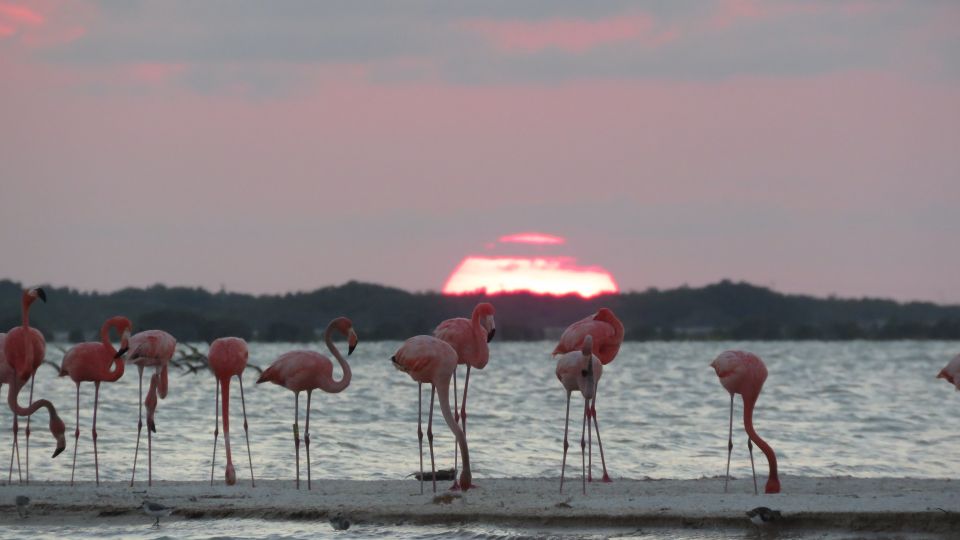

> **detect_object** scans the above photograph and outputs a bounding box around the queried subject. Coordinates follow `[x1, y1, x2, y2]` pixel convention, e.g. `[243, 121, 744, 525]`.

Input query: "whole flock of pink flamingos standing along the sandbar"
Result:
[0, 288, 960, 493]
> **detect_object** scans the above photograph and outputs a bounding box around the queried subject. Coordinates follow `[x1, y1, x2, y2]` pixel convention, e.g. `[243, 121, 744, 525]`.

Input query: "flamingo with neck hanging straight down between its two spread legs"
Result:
[207, 337, 256, 487]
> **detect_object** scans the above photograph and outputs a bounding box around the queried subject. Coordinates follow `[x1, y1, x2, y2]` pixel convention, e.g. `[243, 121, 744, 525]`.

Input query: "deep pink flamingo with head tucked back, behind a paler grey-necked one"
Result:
[553, 308, 623, 482]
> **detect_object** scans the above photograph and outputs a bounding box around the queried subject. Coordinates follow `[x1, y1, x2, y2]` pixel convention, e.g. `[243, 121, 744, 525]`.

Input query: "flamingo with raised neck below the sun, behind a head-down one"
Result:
[433, 302, 497, 474]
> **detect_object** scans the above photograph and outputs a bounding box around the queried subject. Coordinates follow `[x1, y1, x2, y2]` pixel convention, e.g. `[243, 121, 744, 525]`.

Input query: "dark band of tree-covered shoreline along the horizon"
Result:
[0, 280, 960, 342]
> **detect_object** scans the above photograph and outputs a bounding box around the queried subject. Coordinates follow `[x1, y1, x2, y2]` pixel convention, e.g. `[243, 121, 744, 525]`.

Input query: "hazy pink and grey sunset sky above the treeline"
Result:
[0, 0, 960, 303]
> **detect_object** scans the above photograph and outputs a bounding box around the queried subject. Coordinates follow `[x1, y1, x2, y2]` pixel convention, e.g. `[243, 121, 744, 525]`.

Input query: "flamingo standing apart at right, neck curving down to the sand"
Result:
[710, 351, 780, 493]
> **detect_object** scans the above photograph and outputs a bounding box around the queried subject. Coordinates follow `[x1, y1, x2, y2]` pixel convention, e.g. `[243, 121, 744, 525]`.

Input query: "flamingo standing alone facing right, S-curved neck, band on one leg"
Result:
[257, 317, 357, 489]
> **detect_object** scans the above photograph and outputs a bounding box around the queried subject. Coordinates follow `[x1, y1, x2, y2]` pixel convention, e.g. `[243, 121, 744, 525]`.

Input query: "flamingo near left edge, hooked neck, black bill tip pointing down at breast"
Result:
[60, 317, 132, 486]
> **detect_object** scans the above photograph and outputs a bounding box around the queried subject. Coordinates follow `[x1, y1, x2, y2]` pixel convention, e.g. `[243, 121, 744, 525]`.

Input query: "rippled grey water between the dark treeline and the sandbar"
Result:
[9, 336, 960, 481]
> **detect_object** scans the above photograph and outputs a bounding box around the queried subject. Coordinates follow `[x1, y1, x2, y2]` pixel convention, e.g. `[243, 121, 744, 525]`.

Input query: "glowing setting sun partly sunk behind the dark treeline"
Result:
[443, 233, 619, 298]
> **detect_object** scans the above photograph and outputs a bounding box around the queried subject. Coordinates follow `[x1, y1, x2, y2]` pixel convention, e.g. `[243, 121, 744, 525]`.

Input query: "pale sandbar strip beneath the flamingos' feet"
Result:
[0, 476, 960, 532]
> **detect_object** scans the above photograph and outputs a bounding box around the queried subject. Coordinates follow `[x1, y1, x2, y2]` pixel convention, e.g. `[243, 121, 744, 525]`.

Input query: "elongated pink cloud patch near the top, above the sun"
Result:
[466, 14, 673, 53]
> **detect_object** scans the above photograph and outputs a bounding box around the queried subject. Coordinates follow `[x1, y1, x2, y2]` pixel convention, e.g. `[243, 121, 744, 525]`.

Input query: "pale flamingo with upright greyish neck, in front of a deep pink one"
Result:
[557, 334, 603, 495]
